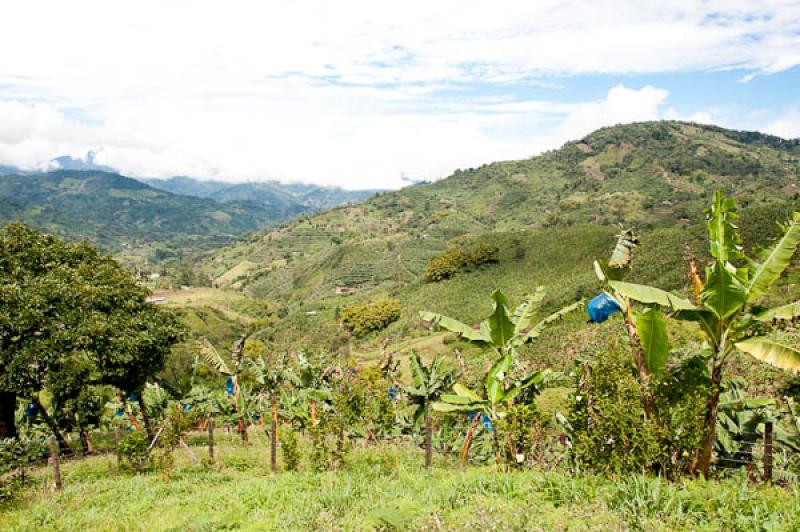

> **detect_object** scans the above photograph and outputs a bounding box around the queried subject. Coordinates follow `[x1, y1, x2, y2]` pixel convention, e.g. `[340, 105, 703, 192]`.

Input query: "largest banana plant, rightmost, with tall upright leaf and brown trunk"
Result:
[608, 191, 800, 477]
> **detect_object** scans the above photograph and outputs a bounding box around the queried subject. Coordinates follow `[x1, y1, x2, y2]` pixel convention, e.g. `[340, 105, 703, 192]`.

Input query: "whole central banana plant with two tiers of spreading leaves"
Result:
[420, 287, 583, 461]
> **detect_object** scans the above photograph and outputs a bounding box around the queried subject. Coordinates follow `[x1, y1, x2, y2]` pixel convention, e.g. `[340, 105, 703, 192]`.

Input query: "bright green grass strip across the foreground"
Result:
[0, 431, 800, 530]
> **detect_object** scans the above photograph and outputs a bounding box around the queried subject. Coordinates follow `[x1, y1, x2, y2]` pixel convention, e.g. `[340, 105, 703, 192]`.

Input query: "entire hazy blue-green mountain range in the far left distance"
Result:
[0, 166, 380, 265]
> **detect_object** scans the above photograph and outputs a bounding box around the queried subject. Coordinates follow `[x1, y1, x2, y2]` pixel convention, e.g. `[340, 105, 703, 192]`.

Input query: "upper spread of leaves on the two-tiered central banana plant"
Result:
[419, 286, 583, 355]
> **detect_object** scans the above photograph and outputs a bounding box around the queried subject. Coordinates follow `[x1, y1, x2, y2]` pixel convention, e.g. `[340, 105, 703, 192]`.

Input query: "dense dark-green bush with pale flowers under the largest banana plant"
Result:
[569, 350, 707, 477]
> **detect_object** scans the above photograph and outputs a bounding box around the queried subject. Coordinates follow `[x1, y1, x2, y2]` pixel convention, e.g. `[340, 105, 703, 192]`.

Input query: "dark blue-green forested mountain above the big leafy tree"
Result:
[0, 170, 276, 263]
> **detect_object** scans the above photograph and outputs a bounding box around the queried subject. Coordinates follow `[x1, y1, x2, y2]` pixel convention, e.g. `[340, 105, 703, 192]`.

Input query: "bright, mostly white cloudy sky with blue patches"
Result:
[0, 0, 800, 188]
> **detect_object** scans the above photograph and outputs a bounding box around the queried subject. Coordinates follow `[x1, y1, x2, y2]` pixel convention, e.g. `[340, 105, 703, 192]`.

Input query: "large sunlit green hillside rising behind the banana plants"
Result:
[198, 122, 800, 370]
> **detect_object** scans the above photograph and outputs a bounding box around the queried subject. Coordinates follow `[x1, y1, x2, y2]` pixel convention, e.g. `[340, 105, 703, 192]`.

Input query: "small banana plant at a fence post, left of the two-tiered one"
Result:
[404, 349, 453, 467]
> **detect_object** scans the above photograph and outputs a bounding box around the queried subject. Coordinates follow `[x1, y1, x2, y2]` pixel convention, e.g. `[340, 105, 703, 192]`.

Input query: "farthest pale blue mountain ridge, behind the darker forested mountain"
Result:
[143, 177, 379, 214]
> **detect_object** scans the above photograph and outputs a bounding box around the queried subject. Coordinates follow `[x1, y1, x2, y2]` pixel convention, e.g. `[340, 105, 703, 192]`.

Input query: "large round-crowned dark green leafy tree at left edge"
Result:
[0, 224, 182, 446]
